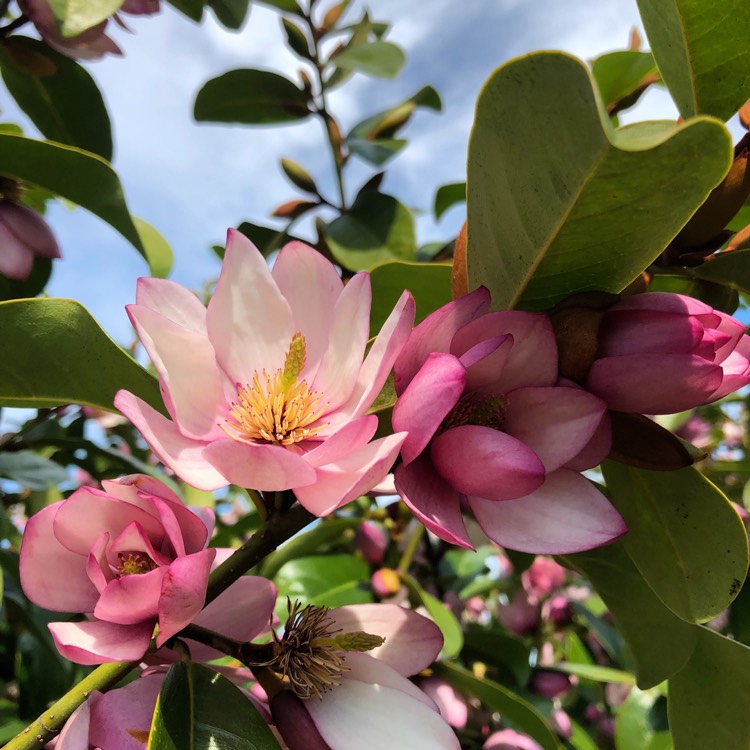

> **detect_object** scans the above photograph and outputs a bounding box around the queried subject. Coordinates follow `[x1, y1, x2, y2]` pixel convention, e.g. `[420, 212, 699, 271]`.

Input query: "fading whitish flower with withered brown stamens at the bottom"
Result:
[264, 604, 459, 750]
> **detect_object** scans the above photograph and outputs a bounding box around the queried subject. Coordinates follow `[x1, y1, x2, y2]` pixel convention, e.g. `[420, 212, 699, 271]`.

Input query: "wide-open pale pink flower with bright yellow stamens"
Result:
[115, 230, 414, 516]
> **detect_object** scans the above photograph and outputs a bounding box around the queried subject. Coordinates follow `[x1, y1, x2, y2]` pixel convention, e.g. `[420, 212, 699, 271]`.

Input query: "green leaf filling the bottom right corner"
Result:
[669, 628, 750, 750]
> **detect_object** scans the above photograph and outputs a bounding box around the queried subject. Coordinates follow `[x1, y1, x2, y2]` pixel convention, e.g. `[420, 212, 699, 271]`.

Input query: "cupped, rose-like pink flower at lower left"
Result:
[20, 475, 225, 664]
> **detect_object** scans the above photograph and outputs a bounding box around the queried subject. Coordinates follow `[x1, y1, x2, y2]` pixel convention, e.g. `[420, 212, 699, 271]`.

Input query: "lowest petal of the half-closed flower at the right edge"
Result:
[586, 354, 722, 414]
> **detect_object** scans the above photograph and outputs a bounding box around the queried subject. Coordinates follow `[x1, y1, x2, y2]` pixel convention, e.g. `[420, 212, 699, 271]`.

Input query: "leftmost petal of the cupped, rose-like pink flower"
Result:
[19, 500, 99, 612]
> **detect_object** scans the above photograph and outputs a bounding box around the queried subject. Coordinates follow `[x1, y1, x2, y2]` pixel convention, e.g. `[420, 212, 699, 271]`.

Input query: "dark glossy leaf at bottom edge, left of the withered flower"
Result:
[148, 662, 280, 750]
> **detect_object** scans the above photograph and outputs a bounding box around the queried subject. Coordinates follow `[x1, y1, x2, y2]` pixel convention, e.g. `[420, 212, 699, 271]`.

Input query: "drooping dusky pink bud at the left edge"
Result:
[0, 200, 60, 281]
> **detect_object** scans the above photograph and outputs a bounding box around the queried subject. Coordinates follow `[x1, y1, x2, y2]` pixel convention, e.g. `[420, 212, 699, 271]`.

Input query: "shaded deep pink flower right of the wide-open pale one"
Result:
[393, 288, 626, 554]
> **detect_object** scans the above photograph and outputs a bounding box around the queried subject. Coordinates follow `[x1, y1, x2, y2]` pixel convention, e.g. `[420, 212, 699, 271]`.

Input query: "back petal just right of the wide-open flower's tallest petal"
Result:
[271, 242, 344, 382]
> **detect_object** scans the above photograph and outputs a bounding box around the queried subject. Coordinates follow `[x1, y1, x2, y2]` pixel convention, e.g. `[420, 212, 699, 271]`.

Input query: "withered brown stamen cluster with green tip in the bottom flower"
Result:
[269, 601, 385, 699]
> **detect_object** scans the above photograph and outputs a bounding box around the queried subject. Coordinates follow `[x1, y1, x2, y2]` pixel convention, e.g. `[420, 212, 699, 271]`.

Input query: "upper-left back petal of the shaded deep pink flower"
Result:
[394, 287, 490, 395]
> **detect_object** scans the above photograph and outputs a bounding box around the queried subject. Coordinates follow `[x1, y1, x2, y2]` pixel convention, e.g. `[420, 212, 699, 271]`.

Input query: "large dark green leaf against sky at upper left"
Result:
[0, 36, 112, 161]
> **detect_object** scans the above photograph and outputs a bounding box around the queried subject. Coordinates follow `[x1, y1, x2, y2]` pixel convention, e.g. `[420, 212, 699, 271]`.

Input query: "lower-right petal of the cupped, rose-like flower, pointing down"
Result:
[156, 549, 216, 646]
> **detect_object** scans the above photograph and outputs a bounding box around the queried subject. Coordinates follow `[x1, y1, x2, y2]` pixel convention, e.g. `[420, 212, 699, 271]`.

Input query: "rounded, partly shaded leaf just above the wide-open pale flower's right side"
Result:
[326, 190, 417, 271]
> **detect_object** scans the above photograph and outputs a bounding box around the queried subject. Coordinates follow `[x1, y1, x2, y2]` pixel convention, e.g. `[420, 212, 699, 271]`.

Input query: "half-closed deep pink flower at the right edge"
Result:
[586, 292, 750, 414]
